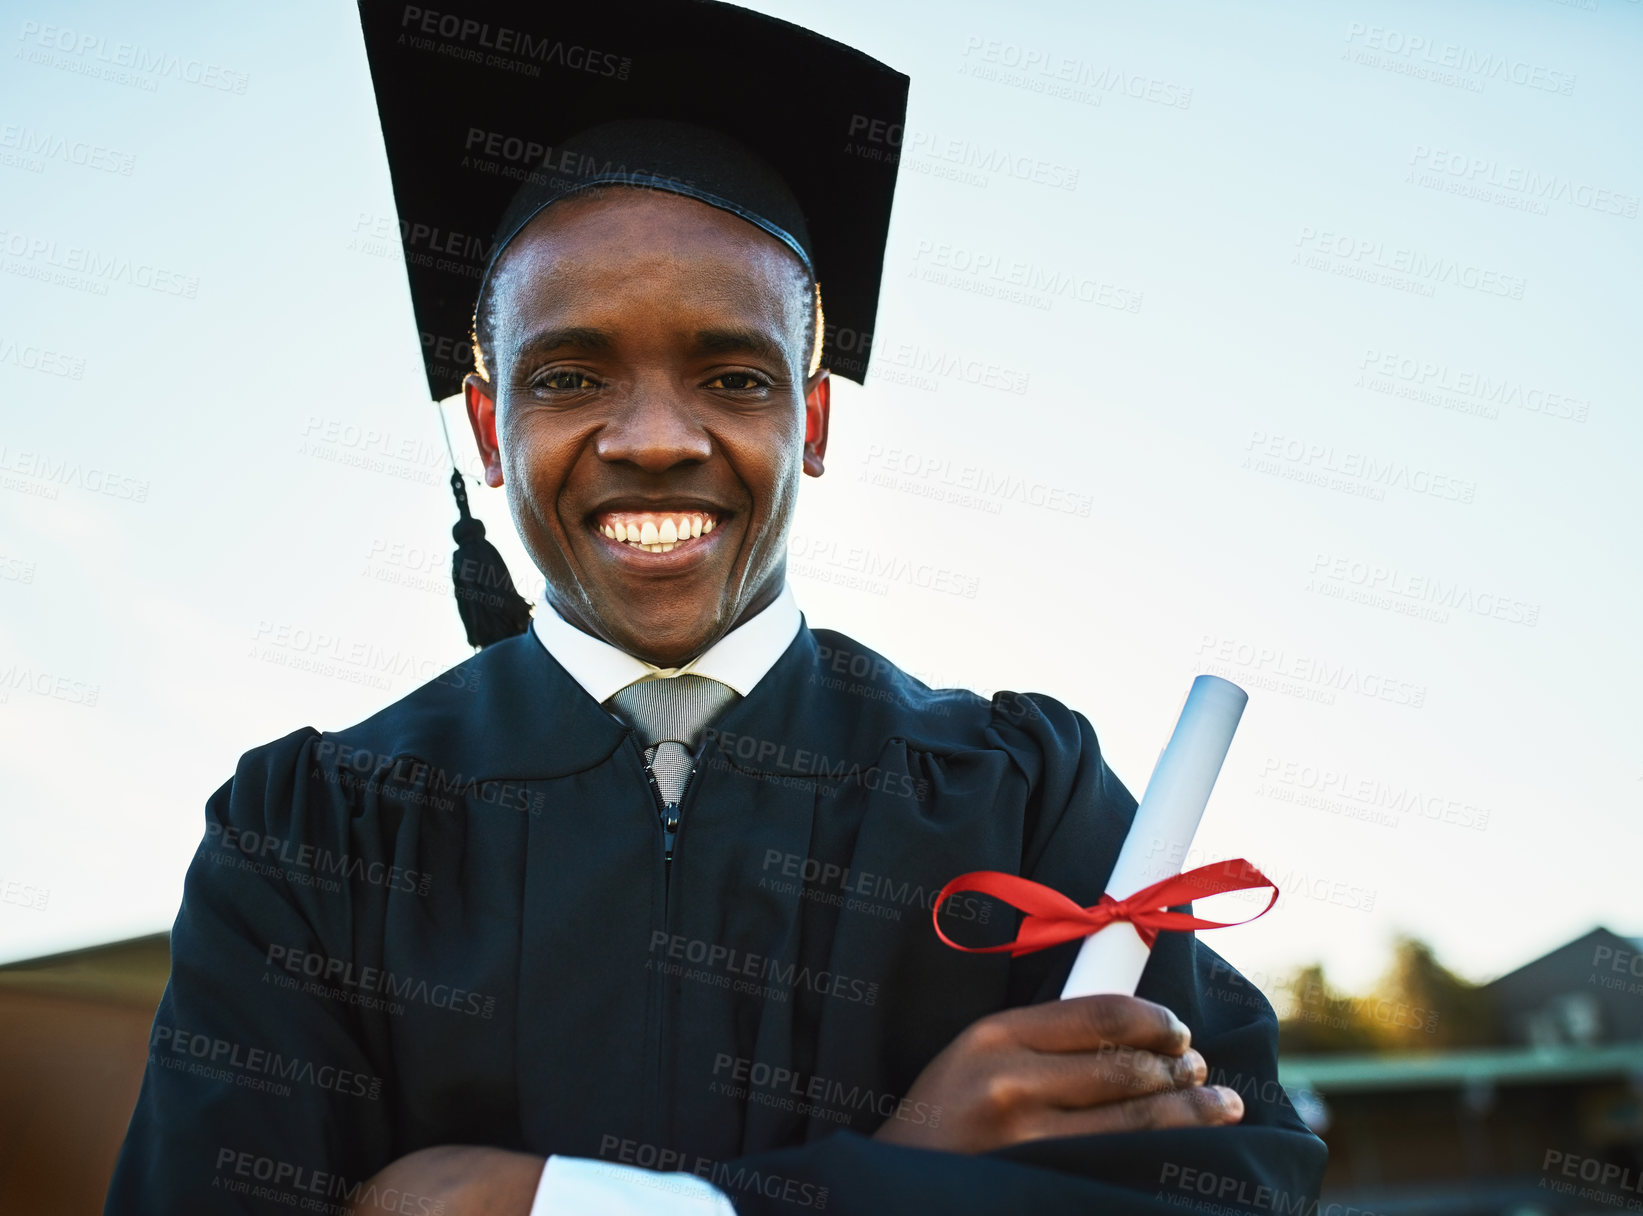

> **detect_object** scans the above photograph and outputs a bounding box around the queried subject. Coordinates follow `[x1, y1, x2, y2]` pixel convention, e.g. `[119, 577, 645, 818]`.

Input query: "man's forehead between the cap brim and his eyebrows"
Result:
[491, 186, 810, 320]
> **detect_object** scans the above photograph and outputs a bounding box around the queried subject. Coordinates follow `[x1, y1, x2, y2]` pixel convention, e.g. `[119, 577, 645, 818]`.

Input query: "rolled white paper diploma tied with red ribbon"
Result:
[1061, 675, 1249, 997]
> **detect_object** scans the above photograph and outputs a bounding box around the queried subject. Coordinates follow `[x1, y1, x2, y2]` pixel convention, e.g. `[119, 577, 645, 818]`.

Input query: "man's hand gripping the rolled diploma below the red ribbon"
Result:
[872, 996, 1244, 1152]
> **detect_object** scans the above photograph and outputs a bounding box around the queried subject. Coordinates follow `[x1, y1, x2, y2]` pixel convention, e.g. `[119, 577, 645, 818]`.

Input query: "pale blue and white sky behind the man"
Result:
[0, 0, 1643, 986]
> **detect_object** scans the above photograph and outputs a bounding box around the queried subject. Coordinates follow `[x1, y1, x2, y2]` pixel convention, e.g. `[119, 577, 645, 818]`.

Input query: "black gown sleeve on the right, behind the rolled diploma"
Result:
[715, 693, 1328, 1216]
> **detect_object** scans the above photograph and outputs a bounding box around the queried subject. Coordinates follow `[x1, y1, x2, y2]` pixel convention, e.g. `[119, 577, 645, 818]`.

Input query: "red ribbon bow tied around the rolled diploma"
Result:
[930, 858, 1278, 955]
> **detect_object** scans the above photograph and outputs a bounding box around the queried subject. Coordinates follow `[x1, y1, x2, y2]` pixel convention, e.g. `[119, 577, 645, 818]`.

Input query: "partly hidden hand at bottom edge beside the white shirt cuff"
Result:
[348, 1144, 547, 1216]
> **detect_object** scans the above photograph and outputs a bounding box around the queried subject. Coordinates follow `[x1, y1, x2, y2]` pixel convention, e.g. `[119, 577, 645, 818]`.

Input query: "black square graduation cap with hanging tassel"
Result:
[360, 0, 909, 646]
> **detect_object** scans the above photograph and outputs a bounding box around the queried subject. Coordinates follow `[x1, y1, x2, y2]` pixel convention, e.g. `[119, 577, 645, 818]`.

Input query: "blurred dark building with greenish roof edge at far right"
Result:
[1280, 928, 1643, 1216]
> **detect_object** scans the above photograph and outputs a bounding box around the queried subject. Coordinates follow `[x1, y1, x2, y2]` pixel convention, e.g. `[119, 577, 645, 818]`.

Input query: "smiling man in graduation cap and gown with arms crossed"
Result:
[108, 2, 1323, 1216]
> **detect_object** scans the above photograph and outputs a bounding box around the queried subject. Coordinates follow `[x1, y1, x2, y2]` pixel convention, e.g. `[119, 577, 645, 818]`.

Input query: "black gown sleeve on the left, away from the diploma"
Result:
[104, 730, 393, 1216]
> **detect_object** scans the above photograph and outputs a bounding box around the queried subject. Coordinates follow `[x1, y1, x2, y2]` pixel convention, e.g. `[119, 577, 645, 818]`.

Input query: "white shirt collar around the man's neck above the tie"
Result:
[531, 583, 803, 705]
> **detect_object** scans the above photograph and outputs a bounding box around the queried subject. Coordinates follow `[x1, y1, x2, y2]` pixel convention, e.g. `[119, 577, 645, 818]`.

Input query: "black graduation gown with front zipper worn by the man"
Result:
[107, 628, 1326, 1216]
